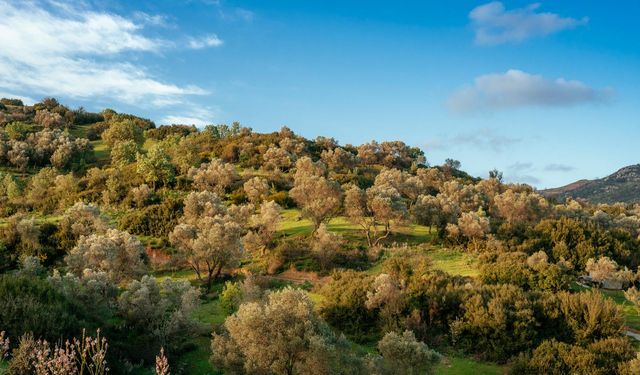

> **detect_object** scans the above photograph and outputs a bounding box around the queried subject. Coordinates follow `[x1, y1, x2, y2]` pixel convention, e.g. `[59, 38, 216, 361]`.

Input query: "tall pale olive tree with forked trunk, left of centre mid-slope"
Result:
[169, 191, 244, 288]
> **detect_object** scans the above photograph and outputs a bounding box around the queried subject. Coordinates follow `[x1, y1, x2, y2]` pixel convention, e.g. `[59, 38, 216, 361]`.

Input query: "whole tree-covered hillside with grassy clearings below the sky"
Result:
[0, 98, 640, 374]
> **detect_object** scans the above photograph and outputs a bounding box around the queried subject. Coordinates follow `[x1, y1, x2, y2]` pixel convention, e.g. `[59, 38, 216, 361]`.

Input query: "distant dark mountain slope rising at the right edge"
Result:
[541, 164, 640, 203]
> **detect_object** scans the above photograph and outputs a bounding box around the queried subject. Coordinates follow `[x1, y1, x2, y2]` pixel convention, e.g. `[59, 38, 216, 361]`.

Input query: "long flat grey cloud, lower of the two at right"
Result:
[448, 69, 613, 113]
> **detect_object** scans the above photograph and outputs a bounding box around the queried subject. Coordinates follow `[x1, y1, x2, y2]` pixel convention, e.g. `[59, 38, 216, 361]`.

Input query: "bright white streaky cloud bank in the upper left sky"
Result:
[0, 1, 205, 103]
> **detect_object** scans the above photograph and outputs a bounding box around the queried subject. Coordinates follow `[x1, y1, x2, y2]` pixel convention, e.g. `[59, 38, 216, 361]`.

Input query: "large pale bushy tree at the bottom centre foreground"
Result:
[211, 288, 360, 375]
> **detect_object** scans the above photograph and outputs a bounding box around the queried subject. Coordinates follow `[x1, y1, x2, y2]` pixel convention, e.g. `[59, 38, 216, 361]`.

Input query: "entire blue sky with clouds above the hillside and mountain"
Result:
[0, 0, 640, 189]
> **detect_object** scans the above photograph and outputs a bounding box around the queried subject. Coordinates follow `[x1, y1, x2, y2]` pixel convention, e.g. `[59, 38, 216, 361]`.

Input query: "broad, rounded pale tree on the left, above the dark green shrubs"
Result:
[65, 229, 147, 282]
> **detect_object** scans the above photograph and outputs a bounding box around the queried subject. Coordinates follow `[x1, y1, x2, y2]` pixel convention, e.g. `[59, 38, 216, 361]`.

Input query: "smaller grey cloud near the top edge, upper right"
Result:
[469, 1, 589, 45]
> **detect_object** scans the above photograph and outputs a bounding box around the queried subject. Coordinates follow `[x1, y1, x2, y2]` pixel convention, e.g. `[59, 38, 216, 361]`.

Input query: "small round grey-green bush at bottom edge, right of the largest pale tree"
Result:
[378, 331, 442, 375]
